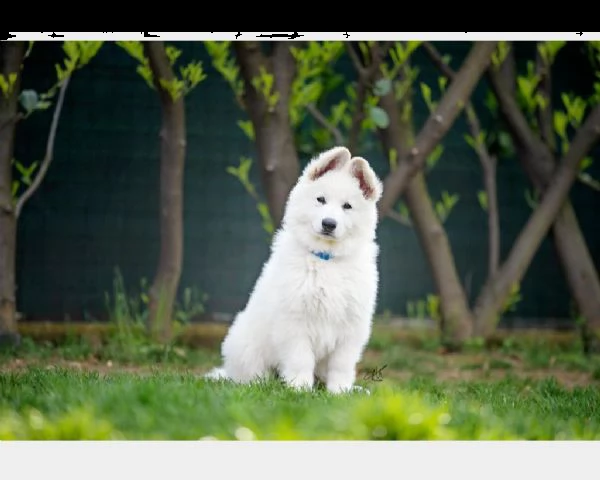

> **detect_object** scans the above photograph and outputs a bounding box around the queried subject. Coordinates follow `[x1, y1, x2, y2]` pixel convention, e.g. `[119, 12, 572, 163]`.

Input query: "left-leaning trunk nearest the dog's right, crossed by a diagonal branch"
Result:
[380, 68, 473, 348]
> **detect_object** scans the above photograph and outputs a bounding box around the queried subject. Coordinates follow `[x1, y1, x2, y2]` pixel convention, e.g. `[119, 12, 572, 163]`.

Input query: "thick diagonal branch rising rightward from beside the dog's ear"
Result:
[379, 42, 498, 218]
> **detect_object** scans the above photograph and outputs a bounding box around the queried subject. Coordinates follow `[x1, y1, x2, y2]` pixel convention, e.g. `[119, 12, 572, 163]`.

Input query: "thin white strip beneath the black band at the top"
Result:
[3, 32, 600, 41]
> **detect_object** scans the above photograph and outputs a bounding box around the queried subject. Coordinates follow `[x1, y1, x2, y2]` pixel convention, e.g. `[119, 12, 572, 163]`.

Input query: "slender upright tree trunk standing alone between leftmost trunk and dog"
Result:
[144, 41, 186, 342]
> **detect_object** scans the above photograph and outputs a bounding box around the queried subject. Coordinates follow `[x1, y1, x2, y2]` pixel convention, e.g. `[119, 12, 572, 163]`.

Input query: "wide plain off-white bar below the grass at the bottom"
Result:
[0, 441, 600, 480]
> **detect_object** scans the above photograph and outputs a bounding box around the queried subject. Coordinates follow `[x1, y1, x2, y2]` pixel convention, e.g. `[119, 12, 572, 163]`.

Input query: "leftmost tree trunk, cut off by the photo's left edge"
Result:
[0, 42, 25, 345]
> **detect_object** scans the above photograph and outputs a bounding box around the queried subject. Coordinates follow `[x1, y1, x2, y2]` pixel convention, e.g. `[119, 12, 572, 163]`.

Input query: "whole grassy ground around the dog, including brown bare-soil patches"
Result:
[0, 320, 600, 440]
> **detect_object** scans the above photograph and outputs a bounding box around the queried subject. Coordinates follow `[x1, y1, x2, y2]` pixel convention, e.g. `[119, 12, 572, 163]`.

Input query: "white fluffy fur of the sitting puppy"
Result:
[207, 147, 382, 393]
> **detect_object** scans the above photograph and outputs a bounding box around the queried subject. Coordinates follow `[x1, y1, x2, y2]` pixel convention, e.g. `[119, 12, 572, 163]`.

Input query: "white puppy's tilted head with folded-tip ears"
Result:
[284, 147, 383, 251]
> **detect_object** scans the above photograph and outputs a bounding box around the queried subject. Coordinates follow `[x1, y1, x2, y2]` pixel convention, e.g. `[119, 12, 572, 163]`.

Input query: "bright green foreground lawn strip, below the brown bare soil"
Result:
[0, 368, 600, 440]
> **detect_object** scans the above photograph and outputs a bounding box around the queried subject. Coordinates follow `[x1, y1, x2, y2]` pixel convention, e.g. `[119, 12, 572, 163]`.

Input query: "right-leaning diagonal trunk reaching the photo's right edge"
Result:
[475, 105, 600, 337]
